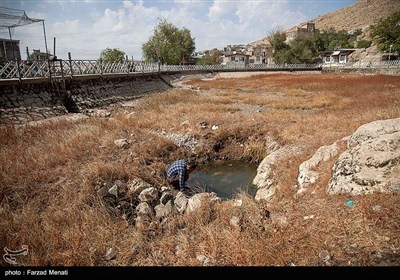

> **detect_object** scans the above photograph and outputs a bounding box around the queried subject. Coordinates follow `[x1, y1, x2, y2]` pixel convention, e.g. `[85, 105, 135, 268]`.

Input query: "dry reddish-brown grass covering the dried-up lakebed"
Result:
[0, 74, 400, 266]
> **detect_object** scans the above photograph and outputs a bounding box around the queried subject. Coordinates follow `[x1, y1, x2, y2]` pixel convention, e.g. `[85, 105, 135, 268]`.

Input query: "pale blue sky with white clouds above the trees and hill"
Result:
[0, 0, 357, 60]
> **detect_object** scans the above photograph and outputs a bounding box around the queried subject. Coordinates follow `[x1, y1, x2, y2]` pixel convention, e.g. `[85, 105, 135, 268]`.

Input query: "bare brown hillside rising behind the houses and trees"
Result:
[251, 0, 400, 45]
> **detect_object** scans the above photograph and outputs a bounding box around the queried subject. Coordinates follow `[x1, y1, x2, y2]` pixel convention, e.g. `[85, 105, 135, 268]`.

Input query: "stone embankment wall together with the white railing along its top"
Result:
[0, 60, 400, 125]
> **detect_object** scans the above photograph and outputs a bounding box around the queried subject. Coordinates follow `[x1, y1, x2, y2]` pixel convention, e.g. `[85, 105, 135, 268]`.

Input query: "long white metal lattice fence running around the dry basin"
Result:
[0, 59, 400, 80]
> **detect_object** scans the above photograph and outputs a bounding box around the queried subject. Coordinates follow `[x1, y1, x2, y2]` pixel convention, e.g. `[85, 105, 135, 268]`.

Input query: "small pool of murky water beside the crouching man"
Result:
[187, 161, 257, 199]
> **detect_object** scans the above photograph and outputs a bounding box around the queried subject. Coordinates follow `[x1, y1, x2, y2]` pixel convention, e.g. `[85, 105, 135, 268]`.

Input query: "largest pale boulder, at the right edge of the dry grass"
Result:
[327, 126, 400, 195]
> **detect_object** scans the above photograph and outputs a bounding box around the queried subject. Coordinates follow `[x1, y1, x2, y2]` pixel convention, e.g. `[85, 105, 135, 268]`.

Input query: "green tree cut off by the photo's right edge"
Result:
[371, 11, 400, 52]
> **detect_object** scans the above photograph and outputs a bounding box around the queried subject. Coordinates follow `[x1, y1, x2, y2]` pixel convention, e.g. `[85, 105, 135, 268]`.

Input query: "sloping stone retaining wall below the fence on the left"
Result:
[0, 73, 180, 124]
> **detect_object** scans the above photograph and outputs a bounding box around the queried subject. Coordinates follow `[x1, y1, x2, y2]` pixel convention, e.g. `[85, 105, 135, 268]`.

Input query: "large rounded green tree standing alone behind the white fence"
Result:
[142, 19, 195, 64]
